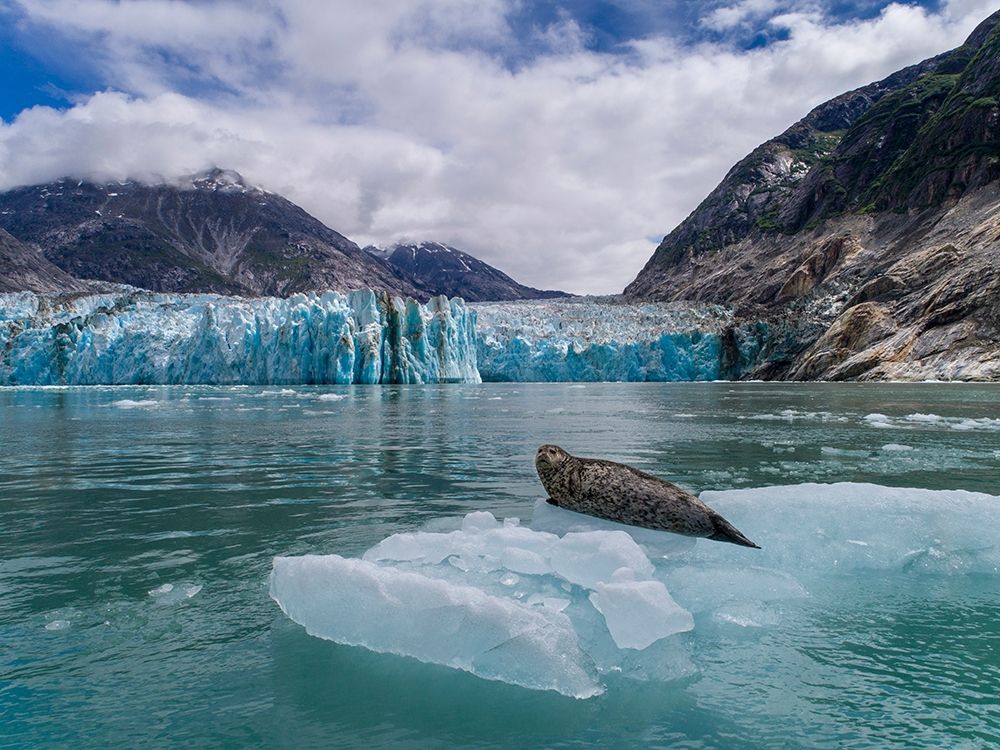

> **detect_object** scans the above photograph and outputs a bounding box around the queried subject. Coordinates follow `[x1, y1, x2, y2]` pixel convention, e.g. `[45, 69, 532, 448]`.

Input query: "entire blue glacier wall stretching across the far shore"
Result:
[0, 288, 766, 385]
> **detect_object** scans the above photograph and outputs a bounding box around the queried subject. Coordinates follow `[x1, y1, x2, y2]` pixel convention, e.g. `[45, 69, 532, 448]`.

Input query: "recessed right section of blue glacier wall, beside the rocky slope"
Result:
[472, 298, 764, 382]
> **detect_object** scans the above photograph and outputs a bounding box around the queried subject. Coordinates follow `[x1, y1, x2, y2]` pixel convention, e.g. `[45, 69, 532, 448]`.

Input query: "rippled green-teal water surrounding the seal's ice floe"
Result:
[0, 383, 1000, 749]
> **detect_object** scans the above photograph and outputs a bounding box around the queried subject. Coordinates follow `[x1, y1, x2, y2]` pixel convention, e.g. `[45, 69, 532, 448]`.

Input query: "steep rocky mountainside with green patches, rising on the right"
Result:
[625, 12, 1000, 379]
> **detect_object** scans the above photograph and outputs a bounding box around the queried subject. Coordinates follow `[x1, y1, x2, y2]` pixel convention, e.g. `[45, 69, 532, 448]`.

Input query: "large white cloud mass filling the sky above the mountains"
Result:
[0, 0, 993, 293]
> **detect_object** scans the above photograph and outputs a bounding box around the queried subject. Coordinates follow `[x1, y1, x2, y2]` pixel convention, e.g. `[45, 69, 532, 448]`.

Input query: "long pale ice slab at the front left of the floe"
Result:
[271, 555, 603, 698]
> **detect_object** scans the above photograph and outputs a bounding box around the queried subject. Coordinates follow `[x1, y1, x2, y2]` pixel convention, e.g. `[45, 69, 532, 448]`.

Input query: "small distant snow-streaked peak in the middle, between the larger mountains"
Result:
[365, 242, 572, 302]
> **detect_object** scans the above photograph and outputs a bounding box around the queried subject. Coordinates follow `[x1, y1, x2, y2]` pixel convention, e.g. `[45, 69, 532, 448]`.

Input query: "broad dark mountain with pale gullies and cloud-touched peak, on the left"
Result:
[0, 169, 424, 296]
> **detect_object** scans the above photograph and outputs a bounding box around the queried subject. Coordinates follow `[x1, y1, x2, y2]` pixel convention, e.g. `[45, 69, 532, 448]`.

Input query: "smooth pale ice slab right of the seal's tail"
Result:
[700, 482, 1000, 576]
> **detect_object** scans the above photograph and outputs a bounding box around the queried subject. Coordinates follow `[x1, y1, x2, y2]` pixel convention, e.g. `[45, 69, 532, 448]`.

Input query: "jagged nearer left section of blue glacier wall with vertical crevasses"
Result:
[0, 290, 479, 385]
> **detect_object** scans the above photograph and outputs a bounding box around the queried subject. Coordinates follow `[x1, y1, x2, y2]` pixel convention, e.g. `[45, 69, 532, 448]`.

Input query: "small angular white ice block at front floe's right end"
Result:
[590, 581, 694, 650]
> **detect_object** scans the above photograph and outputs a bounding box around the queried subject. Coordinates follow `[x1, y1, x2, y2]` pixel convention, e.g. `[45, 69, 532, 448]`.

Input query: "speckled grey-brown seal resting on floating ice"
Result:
[535, 445, 760, 549]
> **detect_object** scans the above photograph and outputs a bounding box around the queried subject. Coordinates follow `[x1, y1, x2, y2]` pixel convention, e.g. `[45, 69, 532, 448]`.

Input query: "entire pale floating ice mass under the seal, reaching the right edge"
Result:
[270, 483, 1000, 699]
